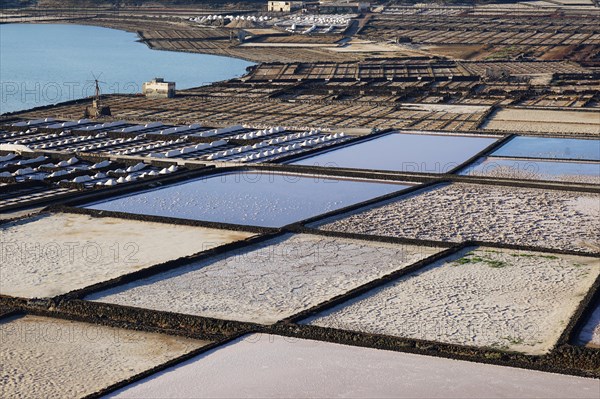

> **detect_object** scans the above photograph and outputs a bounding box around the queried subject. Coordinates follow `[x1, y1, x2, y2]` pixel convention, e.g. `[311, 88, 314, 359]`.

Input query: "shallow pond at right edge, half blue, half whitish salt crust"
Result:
[460, 157, 600, 184]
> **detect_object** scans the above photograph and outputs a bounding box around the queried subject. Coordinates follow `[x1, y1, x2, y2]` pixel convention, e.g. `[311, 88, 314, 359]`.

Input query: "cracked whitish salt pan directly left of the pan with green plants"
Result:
[87, 235, 440, 324]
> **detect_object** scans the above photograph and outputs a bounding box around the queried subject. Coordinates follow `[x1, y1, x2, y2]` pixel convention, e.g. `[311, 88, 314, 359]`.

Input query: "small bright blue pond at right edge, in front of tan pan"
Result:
[492, 136, 600, 161]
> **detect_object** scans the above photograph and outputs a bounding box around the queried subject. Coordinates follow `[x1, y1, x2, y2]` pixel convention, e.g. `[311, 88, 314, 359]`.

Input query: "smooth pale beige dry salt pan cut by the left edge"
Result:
[0, 213, 251, 298]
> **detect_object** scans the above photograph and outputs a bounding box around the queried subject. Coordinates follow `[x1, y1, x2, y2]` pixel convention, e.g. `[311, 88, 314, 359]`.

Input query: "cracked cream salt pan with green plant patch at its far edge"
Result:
[304, 247, 600, 354]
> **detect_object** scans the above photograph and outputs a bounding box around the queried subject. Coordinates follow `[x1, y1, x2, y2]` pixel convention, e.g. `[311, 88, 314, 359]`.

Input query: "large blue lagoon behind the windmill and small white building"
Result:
[0, 24, 252, 114]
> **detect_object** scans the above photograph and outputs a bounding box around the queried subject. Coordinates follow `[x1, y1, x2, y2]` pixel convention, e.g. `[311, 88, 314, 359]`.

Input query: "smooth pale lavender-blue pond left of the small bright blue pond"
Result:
[292, 133, 497, 173]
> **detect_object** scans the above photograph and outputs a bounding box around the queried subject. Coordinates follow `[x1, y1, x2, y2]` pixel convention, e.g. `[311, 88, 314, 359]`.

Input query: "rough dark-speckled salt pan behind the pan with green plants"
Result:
[321, 184, 600, 252]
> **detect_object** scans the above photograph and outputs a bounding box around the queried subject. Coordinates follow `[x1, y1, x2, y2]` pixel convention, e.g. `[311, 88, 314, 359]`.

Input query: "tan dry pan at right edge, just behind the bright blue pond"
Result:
[482, 108, 600, 134]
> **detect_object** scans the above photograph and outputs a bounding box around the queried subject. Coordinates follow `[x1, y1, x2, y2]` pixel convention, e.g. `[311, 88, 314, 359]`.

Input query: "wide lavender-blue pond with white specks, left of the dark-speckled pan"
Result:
[86, 172, 409, 227]
